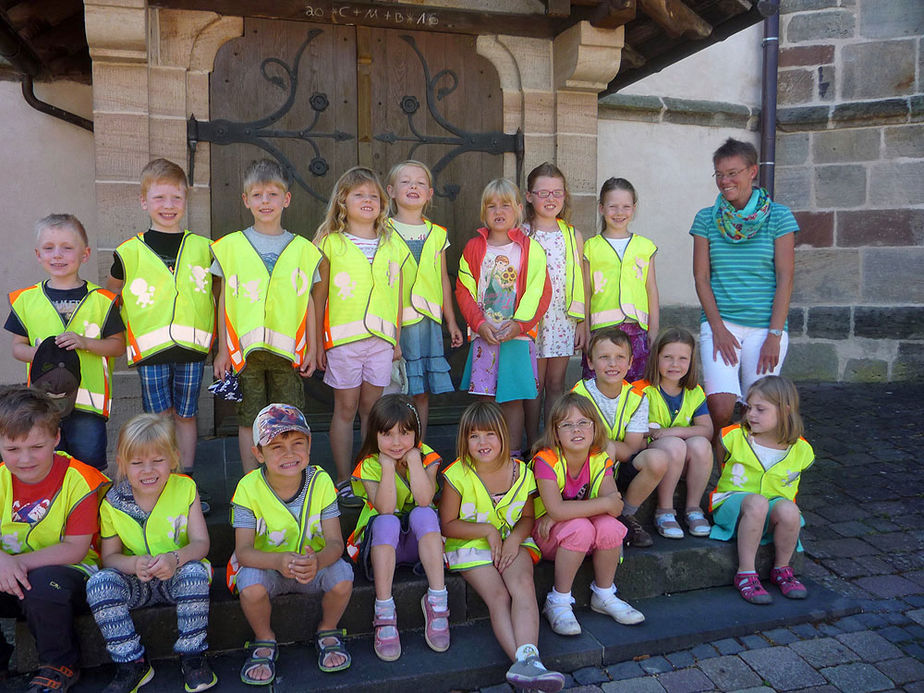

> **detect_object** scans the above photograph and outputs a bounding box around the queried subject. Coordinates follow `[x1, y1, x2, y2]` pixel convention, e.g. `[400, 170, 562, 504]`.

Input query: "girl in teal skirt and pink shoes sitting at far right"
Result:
[709, 375, 815, 604]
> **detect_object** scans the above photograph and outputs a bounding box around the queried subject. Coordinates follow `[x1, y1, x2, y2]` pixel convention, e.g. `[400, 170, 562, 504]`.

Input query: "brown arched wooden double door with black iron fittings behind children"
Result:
[207, 19, 512, 425]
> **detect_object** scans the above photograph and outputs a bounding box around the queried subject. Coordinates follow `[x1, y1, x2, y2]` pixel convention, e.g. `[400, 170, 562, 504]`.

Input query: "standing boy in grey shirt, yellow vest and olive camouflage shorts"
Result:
[211, 159, 321, 474]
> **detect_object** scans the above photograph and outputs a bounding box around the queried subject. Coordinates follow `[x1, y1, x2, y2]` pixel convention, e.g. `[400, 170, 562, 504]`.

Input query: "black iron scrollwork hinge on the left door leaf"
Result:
[186, 29, 355, 202]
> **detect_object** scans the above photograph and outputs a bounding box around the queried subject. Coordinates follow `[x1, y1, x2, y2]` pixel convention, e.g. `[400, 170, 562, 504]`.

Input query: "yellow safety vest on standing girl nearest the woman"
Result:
[584, 234, 657, 330]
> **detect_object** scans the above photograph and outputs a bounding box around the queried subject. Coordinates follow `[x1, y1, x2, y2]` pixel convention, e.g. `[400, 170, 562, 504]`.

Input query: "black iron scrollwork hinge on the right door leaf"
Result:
[375, 34, 523, 200]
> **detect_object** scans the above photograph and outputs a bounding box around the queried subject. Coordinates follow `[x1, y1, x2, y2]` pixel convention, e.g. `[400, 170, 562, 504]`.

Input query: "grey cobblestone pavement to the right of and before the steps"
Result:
[482, 384, 924, 693]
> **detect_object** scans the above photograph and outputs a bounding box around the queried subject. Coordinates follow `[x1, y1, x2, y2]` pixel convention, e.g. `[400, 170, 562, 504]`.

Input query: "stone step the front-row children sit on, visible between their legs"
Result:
[9, 536, 798, 671]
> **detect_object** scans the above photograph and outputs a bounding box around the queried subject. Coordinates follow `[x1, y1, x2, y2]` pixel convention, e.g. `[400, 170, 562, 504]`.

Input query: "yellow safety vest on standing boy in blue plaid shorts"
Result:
[116, 231, 215, 365]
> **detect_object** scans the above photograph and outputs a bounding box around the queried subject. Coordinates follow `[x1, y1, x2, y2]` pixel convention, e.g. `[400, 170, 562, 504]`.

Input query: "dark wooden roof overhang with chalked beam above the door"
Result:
[0, 0, 764, 94]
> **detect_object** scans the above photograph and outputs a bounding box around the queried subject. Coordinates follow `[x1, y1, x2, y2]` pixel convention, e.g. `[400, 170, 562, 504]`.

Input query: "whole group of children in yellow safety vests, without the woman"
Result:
[0, 153, 813, 693]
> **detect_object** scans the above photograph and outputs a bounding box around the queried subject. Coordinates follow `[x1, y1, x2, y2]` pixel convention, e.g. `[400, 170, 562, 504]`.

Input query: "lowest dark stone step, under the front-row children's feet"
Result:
[0, 580, 860, 693]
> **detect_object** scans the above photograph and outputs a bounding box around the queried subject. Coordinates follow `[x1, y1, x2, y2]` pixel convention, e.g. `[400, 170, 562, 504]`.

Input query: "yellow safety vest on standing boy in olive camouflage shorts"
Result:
[212, 231, 321, 372]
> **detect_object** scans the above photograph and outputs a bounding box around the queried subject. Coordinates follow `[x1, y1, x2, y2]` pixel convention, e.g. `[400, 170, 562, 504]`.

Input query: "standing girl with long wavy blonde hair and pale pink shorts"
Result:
[313, 167, 411, 507]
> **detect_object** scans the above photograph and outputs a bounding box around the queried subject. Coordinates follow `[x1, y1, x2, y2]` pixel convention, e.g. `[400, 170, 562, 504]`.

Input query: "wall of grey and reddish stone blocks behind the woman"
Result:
[776, 0, 924, 381]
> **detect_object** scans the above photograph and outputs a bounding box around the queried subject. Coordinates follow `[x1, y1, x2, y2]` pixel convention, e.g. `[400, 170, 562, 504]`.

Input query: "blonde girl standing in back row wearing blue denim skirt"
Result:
[386, 161, 462, 437]
